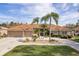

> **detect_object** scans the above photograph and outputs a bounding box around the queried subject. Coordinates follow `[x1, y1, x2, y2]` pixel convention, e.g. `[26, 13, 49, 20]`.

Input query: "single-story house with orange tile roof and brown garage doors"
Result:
[8, 24, 68, 37]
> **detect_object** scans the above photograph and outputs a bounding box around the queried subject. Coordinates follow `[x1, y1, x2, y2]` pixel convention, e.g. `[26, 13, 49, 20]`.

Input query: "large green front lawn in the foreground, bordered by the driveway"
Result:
[4, 45, 79, 56]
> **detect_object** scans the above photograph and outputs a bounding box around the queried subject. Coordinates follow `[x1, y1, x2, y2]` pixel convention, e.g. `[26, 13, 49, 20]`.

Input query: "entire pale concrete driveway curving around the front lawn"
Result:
[0, 37, 79, 56]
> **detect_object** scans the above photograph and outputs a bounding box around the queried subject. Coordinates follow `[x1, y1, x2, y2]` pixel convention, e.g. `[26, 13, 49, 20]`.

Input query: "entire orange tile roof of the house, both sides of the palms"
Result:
[8, 24, 67, 31]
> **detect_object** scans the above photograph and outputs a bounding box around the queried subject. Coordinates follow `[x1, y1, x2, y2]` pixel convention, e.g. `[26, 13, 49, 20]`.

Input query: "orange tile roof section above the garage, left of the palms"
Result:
[8, 24, 38, 31]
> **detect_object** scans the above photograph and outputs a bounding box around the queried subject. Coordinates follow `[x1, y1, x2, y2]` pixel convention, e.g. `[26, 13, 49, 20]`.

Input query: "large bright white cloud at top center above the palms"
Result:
[18, 3, 57, 17]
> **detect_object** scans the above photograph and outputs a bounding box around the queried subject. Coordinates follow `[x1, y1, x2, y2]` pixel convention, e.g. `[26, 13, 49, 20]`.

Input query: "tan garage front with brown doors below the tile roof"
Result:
[8, 31, 32, 37]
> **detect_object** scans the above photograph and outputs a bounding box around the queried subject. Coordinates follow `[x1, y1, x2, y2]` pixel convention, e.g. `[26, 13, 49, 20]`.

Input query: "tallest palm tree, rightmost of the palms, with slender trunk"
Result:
[45, 12, 59, 41]
